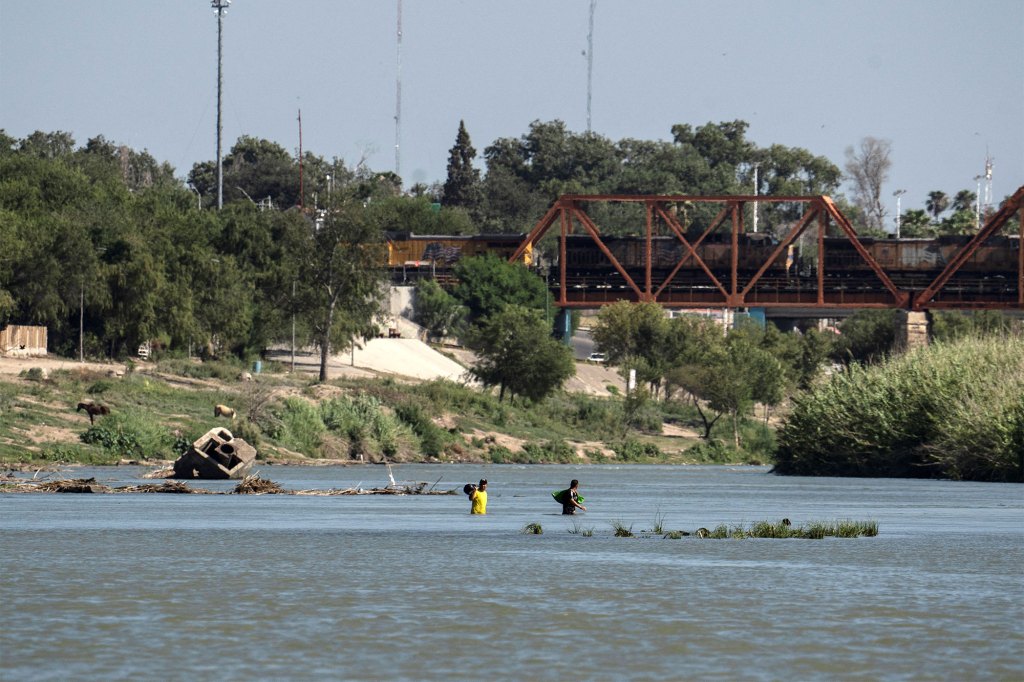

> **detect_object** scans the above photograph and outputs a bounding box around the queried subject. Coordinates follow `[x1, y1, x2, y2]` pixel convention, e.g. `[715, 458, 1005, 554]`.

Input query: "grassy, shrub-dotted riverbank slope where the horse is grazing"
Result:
[0, 359, 771, 466]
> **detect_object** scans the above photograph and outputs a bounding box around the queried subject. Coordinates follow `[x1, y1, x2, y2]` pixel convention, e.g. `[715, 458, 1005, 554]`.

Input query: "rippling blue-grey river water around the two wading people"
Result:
[0, 465, 1024, 680]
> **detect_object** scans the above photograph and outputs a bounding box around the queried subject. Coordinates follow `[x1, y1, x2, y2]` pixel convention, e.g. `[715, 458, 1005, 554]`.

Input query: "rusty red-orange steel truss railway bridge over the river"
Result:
[510, 186, 1024, 311]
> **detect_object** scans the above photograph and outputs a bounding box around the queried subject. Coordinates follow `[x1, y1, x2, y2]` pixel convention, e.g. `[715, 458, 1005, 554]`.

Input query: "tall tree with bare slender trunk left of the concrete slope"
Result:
[288, 190, 387, 381]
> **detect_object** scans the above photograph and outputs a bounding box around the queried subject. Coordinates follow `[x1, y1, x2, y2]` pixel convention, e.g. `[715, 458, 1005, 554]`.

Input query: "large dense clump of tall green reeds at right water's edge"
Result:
[775, 336, 1024, 481]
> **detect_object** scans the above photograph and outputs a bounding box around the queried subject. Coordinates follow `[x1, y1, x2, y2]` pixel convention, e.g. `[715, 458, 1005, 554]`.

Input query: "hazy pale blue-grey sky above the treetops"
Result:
[0, 0, 1024, 220]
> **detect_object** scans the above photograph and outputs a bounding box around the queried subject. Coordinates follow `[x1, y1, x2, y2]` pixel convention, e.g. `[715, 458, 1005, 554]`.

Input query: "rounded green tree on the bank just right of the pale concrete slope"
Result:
[470, 305, 575, 401]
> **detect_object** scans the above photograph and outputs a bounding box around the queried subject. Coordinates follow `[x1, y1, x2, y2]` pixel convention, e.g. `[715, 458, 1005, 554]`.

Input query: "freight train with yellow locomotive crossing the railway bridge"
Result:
[387, 232, 1020, 291]
